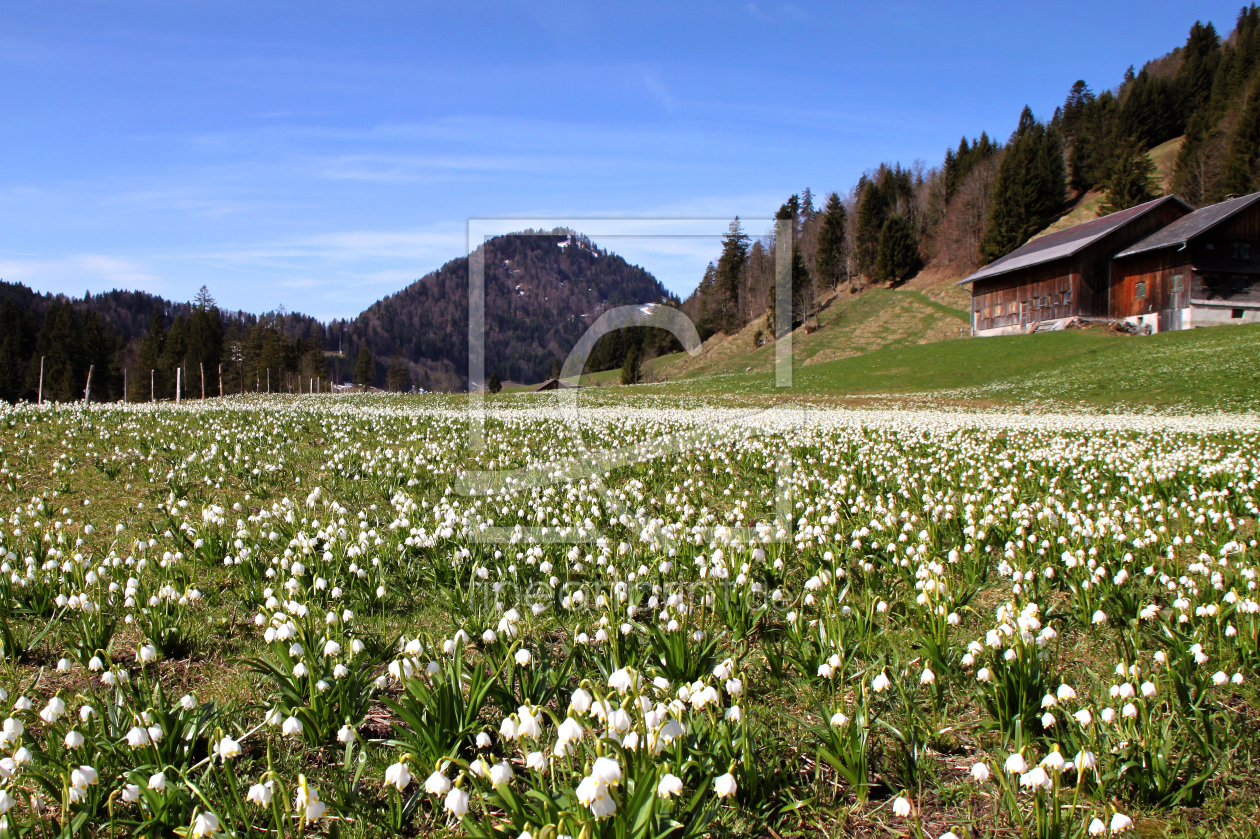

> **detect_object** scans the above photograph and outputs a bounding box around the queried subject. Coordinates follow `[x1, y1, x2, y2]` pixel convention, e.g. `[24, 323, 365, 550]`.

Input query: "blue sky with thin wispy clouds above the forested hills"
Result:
[0, 0, 1239, 317]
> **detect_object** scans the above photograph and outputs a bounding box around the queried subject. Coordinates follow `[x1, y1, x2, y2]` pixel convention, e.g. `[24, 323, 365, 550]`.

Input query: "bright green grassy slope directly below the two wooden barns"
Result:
[635, 326, 1260, 411]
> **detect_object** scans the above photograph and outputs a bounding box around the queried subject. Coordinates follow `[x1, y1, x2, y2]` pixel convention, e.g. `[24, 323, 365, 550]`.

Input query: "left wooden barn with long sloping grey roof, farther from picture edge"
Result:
[959, 195, 1193, 336]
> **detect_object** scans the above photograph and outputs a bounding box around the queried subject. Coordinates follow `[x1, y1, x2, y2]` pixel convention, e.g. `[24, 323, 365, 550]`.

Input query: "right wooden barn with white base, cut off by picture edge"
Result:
[1110, 193, 1260, 333]
